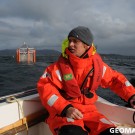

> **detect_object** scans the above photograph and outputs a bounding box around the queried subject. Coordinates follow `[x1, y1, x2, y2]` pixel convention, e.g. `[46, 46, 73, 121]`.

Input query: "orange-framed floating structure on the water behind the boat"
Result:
[16, 42, 36, 63]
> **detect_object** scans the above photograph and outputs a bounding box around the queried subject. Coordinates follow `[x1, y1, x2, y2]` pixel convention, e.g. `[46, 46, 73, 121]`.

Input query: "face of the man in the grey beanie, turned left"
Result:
[68, 37, 89, 57]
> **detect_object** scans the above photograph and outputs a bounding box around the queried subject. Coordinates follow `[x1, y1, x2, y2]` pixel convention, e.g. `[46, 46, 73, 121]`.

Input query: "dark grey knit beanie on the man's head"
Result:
[68, 26, 93, 46]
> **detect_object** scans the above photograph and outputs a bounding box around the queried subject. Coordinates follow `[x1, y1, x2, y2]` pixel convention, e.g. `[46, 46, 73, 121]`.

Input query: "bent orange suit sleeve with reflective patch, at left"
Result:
[37, 66, 72, 115]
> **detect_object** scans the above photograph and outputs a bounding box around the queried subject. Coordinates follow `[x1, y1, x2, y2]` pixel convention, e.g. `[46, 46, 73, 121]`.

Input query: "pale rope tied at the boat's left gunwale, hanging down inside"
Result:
[6, 96, 29, 135]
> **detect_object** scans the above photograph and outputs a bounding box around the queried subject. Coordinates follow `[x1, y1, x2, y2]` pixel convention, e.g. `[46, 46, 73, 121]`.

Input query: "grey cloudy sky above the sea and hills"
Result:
[0, 0, 135, 55]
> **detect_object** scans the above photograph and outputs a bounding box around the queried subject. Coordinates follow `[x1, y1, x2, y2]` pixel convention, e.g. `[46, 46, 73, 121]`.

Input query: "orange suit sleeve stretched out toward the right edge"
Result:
[101, 63, 135, 101]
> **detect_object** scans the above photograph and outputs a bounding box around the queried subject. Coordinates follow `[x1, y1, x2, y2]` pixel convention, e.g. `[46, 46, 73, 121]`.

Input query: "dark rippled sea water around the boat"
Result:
[0, 55, 135, 105]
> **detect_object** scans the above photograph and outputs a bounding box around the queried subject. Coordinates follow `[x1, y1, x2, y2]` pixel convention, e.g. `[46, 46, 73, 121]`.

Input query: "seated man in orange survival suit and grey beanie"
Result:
[37, 26, 135, 135]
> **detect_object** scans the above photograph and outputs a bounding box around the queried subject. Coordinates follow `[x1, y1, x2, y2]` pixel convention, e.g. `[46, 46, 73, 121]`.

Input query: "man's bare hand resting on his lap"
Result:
[66, 107, 83, 119]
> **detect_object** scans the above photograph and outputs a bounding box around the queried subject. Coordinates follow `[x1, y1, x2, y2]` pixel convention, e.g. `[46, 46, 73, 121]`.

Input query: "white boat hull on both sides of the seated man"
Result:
[0, 94, 135, 135]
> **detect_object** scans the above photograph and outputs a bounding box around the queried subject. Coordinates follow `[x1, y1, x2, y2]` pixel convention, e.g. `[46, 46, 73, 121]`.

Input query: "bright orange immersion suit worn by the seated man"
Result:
[37, 47, 135, 135]
